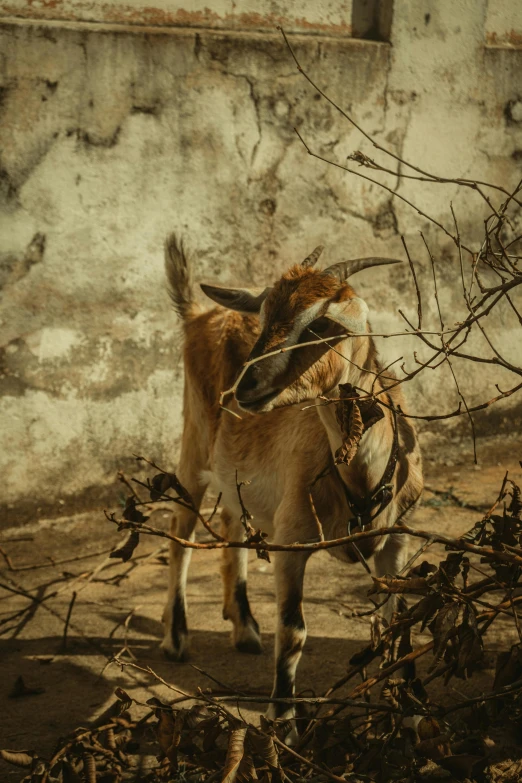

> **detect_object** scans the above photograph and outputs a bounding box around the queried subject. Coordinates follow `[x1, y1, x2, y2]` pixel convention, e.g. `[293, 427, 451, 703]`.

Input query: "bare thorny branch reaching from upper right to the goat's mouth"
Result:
[216, 28, 522, 461]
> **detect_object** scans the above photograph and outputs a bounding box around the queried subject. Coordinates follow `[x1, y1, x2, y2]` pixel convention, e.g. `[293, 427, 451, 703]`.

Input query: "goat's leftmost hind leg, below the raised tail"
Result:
[161, 487, 204, 661]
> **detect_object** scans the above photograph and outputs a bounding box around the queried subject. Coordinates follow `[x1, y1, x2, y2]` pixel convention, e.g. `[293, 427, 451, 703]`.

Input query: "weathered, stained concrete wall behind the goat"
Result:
[0, 0, 522, 520]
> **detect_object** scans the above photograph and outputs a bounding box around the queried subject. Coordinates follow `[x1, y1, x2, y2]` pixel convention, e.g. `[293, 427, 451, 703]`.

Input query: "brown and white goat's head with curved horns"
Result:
[201, 247, 397, 413]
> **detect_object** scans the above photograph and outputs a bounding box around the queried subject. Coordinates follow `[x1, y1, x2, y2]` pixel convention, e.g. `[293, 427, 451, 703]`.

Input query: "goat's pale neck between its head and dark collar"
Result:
[317, 338, 393, 494]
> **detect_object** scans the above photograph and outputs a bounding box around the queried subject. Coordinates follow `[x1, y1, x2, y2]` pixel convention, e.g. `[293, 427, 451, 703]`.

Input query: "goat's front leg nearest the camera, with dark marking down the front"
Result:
[267, 552, 309, 743]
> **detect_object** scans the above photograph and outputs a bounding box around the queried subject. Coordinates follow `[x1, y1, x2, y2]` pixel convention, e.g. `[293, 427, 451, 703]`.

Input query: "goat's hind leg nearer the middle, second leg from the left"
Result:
[221, 509, 262, 654]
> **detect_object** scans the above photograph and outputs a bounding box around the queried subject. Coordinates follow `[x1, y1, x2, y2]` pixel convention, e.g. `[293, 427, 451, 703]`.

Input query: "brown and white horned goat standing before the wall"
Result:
[162, 235, 423, 732]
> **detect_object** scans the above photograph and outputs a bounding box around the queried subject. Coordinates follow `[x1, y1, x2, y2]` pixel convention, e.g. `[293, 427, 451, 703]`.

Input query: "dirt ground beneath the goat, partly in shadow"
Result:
[0, 447, 522, 781]
